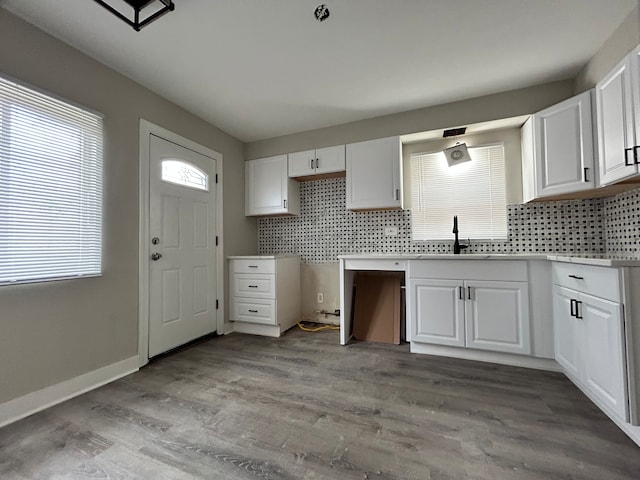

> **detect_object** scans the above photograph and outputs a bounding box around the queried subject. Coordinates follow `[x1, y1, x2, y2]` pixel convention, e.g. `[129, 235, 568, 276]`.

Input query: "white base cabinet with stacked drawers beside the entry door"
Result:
[229, 255, 301, 337]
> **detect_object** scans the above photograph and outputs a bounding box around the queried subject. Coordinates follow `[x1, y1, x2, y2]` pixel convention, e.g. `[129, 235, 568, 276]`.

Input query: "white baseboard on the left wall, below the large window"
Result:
[0, 355, 140, 427]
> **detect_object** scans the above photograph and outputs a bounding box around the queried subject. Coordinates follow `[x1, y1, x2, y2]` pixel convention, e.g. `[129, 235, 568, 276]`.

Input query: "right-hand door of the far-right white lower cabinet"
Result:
[578, 294, 628, 421]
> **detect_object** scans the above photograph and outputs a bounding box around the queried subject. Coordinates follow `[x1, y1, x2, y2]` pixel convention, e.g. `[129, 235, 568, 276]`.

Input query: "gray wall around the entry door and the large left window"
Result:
[0, 8, 257, 403]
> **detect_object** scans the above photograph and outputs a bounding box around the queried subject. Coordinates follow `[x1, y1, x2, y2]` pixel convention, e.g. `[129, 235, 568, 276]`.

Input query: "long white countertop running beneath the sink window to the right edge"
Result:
[338, 253, 640, 267]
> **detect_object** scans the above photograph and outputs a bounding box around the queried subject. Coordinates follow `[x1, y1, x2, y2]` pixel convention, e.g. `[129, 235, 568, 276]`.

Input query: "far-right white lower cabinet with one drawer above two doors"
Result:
[553, 265, 629, 421]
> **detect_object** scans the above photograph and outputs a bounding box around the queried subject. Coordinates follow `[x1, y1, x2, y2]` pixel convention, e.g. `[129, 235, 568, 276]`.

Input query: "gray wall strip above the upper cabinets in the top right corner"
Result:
[575, 2, 640, 93]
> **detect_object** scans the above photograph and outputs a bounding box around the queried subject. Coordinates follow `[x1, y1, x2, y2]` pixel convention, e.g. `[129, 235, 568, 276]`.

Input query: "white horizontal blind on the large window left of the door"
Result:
[0, 77, 102, 284]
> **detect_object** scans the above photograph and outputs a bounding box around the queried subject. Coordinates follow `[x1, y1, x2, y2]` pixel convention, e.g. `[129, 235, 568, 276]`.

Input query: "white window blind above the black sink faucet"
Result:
[411, 145, 507, 240]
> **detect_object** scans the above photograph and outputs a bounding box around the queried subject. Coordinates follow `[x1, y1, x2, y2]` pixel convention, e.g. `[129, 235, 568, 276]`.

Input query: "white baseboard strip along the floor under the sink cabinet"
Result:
[411, 342, 562, 372]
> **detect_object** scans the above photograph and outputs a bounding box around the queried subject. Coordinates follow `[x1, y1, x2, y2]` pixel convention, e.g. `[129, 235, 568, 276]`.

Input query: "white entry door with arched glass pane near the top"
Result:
[149, 135, 217, 357]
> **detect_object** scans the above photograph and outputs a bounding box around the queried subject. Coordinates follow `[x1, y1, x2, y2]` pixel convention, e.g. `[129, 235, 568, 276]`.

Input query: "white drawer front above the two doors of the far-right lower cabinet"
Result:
[553, 262, 620, 302]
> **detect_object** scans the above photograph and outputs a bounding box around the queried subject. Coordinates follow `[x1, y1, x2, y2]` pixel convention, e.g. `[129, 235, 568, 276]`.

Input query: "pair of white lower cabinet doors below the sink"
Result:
[409, 267, 531, 355]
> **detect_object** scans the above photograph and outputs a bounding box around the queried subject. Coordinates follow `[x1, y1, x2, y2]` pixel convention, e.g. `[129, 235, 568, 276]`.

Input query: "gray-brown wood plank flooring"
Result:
[0, 328, 640, 480]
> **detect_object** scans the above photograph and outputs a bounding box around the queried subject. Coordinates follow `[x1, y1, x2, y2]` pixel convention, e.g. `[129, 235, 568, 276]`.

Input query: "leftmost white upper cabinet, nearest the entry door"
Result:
[245, 155, 300, 216]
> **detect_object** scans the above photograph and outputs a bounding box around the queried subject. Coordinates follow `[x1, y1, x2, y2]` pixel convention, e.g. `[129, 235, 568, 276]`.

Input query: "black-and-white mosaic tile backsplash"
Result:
[258, 178, 640, 264]
